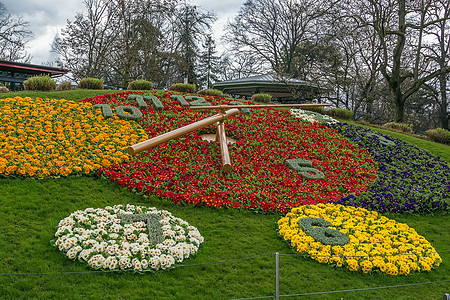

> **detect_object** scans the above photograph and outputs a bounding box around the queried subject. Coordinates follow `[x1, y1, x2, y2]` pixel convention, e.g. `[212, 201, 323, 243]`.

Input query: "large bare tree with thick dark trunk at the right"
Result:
[357, 0, 450, 122]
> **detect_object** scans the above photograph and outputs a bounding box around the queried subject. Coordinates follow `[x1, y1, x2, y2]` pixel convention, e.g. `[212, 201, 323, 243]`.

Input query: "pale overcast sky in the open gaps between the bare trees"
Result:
[0, 0, 245, 64]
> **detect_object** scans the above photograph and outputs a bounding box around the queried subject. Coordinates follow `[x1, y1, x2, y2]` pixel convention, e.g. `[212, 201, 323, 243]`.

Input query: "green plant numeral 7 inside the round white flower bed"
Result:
[118, 214, 164, 245]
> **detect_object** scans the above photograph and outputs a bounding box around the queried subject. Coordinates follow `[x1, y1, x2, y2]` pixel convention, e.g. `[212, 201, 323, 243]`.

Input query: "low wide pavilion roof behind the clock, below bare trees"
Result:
[213, 74, 320, 98]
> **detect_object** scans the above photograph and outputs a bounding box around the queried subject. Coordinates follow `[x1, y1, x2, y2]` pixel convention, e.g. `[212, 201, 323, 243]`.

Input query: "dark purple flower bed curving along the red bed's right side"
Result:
[328, 123, 450, 214]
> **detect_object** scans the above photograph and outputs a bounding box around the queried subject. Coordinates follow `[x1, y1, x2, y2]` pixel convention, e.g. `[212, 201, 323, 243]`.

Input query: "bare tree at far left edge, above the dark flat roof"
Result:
[0, 2, 33, 62]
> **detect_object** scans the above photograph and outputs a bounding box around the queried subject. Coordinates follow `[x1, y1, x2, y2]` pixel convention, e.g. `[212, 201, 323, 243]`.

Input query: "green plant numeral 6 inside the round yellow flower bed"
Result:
[298, 217, 350, 246]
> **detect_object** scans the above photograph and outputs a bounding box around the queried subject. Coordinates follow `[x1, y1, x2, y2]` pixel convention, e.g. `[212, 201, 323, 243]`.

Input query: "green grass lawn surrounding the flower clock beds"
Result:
[0, 90, 450, 299]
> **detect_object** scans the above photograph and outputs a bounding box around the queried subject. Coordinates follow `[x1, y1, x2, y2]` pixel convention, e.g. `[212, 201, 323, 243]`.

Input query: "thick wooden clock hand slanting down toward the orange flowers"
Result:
[127, 108, 239, 155]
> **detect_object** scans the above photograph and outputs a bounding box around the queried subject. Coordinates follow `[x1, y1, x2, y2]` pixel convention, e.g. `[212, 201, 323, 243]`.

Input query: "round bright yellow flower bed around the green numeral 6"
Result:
[278, 204, 442, 275]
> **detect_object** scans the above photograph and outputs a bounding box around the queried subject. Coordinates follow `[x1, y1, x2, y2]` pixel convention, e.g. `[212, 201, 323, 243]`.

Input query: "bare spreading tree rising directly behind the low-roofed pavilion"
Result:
[225, 0, 336, 77]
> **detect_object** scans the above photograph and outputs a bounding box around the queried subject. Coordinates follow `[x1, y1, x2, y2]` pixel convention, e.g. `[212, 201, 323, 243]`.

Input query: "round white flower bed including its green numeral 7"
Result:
[54, 204, 203, 271]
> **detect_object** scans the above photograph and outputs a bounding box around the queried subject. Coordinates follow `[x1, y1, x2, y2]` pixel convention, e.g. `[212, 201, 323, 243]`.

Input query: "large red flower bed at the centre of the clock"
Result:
[84, 92, 377, 214]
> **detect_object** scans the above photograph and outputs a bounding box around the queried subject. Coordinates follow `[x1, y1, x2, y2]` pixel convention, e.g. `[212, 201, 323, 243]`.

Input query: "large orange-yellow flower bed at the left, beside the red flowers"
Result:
[0, 97, 148, 177]
